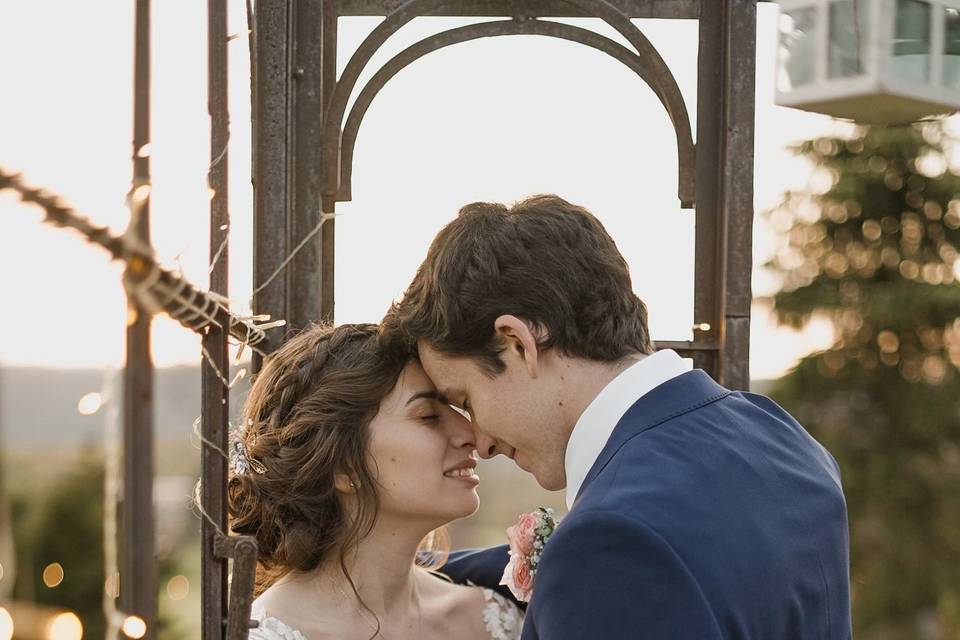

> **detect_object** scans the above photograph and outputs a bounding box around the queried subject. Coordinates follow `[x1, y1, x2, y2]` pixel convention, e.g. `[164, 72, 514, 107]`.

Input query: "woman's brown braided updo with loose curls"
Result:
[228, 324, 406, 595]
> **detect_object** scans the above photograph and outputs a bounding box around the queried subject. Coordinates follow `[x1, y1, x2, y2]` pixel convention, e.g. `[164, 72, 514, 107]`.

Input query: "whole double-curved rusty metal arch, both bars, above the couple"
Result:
[320, 0, 696, 212]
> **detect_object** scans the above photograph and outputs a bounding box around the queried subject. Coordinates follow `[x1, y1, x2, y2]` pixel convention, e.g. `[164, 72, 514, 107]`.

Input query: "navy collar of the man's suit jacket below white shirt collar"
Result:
[574, 369, 731, 506]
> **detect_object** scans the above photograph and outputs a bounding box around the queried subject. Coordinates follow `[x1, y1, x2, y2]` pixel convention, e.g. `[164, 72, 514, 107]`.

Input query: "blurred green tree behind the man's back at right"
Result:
[768, 122, 960, 640]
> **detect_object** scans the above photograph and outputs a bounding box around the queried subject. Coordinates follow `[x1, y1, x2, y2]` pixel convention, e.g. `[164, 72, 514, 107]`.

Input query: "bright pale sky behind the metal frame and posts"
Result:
[0, 0, 839, 378]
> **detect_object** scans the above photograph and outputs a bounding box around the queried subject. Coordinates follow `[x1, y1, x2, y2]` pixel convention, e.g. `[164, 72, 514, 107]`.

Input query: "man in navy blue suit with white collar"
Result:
[383, 196, 851, 640]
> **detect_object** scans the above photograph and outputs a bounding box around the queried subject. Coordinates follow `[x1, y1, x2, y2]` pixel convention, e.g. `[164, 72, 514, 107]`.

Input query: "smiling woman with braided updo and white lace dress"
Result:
[229, 325, 523, 640]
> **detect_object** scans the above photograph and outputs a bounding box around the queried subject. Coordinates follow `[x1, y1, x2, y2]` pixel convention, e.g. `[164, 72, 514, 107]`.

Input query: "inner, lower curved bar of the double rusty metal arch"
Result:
[334, 20, 696, 208]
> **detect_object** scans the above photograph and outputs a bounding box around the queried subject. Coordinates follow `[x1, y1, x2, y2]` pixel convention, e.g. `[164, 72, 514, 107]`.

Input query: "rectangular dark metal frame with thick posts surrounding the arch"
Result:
[254, 0, 761, 389]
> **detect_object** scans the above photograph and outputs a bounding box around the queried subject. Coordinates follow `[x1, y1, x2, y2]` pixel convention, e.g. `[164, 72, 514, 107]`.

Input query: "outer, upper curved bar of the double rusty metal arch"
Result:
[321, 0, 695, 208]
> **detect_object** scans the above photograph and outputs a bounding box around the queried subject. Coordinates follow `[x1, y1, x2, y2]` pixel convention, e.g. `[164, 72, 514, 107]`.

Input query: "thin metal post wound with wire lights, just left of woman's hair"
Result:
[200, 0, 230, 640]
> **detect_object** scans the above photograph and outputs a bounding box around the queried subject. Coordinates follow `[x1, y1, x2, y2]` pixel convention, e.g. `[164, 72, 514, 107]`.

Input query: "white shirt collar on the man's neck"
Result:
[564, 349, 693, 509]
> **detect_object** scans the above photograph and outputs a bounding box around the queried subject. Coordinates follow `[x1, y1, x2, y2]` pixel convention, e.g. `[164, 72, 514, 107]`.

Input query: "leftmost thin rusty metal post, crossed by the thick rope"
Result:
[120, 0, 157, 639]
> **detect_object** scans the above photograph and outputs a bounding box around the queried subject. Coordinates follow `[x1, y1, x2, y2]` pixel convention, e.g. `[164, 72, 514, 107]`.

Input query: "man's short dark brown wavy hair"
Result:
[381, 195, 653, 377]
